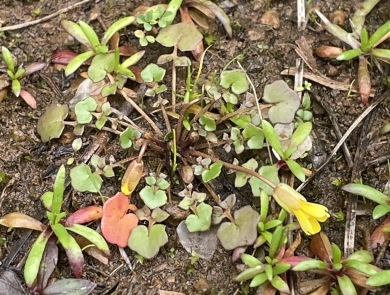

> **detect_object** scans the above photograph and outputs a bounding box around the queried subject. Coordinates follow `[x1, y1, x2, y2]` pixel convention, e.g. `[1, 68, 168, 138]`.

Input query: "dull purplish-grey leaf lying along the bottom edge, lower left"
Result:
[42, 279, 96, 295]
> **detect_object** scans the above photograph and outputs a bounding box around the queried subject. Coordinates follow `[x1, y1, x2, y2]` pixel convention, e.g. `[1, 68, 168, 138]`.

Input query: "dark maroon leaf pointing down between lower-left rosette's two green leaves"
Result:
[34, 236, 58, 292]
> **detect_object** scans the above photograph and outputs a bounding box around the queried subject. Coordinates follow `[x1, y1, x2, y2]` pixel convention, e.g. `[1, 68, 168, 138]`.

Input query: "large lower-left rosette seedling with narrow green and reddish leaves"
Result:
[0, 166, 110, 290]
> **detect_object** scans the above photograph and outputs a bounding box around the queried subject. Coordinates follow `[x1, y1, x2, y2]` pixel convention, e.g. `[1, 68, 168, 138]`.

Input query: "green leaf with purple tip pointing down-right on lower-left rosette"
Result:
[52, 223, 84, 278]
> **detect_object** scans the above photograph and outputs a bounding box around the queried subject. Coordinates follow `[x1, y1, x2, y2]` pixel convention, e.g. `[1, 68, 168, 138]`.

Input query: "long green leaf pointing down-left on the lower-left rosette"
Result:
[24, 227, 53, 289]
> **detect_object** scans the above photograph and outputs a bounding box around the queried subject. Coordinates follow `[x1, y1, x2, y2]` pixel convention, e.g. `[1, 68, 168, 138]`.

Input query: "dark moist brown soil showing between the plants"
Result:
[0, 0, 390, 295]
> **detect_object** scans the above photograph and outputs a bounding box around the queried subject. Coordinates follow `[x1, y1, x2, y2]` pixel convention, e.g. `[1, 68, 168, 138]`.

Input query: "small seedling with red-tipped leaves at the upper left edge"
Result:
[0, 46, 46, 109]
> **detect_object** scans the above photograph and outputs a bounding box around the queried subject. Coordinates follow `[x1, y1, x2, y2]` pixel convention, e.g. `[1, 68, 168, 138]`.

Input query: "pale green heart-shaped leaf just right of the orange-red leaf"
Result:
[128, 224, 168, 259]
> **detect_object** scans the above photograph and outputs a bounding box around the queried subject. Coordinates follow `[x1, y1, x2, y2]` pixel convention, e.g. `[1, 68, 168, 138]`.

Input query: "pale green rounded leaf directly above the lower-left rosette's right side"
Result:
[70, 164, 103, 193]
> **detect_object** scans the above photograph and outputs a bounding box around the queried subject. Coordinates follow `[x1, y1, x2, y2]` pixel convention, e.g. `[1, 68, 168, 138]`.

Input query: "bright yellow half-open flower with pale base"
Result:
[273, 183, 329, 235]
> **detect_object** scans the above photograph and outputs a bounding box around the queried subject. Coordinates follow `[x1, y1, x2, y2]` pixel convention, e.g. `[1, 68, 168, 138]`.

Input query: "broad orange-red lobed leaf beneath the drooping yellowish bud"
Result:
[101, 192, 138, 248]
